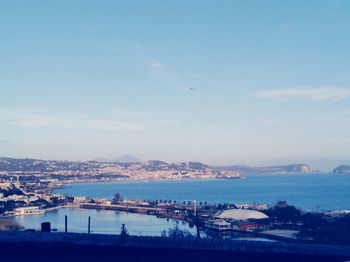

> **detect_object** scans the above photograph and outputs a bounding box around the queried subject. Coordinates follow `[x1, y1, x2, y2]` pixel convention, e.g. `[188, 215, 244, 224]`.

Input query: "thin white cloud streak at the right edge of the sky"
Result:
[257, 87, 350, 100]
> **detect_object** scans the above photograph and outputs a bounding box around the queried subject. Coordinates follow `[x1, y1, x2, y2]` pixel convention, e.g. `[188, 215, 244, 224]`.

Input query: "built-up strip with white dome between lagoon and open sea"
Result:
[74, 194, 270, 232]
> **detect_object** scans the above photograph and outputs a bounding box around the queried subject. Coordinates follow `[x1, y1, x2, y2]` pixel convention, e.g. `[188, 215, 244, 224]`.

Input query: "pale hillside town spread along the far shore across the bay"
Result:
[0, 158, 240, 183]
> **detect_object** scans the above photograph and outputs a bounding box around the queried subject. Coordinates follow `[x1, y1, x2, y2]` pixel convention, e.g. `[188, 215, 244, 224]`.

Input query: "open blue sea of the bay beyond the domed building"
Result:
[56, 174, 350, 210]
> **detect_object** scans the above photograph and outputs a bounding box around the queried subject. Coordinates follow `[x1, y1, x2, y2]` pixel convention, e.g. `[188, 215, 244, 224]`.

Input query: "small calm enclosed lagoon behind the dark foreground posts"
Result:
[13, 208, 195, 236]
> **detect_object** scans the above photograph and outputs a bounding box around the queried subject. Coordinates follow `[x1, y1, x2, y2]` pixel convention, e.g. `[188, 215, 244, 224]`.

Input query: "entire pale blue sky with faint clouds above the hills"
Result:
[0, 0, 350, 169]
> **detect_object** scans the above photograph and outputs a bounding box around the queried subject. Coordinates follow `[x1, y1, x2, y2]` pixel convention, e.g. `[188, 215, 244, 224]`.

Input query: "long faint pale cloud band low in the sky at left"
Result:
[0, 107, 146, 131]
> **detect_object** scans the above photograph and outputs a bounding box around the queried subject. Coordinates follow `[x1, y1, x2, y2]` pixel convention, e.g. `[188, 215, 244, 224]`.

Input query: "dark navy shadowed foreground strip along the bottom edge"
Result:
[0, 232, 350, 262]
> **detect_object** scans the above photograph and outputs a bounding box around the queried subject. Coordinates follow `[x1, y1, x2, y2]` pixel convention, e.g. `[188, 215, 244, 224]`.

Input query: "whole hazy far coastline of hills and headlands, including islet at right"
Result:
[0, 155, 350, 181]
